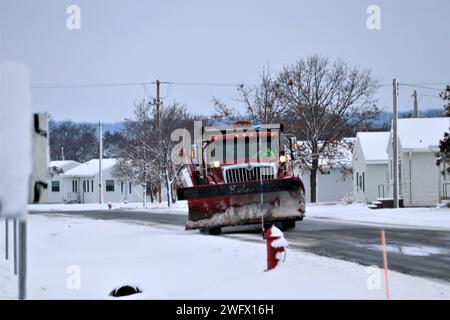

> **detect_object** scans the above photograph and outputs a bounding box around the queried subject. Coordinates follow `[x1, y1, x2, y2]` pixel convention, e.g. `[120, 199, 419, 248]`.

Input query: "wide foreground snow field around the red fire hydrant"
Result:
[0, 215, 450, 299]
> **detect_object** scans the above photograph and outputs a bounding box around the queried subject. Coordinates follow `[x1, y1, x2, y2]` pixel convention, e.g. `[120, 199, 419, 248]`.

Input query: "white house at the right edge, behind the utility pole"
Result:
[386, 118, 450, 207]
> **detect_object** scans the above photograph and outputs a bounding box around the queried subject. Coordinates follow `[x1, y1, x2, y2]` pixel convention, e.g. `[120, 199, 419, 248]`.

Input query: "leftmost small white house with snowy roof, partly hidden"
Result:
[48, 160, 80, 203]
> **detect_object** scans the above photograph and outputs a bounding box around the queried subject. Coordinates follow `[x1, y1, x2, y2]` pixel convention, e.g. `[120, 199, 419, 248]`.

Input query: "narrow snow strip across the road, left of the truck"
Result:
[28, 201, 187, 214]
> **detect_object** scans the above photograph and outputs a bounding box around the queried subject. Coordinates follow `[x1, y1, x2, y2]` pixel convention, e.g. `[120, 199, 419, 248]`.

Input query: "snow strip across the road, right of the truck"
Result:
[305, 204, 450, 229]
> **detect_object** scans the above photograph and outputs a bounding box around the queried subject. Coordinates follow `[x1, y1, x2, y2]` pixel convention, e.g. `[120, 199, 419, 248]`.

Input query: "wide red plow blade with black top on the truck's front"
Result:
[177, 178, 305, 229]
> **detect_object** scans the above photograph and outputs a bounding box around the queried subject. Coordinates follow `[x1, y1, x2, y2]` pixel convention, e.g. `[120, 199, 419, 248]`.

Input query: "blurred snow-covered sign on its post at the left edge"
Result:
[0, 62, 33, 299]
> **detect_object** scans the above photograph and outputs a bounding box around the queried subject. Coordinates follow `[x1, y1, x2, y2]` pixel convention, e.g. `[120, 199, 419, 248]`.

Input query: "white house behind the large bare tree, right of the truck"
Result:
[299, 138, 354, 202]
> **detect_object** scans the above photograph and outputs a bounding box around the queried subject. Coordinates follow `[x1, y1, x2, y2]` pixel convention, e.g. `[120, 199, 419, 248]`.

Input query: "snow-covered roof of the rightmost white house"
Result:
[397, 118, 450, 151]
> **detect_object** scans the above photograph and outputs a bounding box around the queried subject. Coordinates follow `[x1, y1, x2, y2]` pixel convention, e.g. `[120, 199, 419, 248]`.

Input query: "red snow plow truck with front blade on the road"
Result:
[177, 122, 305, 234]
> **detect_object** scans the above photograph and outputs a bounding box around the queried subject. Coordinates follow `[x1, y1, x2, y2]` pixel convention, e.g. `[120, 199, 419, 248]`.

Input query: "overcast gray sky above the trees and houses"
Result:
[0, 0, 450, 122]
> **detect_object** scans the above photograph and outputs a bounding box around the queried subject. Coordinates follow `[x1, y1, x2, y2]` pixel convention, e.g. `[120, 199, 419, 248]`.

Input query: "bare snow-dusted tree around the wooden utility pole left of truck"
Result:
[114, 101, 193, 205]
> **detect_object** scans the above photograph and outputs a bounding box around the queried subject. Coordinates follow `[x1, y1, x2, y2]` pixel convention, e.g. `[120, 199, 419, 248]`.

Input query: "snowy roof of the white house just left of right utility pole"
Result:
[356, 132, 389, 162]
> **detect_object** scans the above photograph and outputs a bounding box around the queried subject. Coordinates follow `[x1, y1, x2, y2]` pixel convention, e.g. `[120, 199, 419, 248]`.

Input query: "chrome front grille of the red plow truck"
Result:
[223, 166, 275, 183]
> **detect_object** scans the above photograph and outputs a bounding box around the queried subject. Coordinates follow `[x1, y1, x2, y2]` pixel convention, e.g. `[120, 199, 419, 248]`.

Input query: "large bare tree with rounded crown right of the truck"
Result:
[277, 55, 379, 202]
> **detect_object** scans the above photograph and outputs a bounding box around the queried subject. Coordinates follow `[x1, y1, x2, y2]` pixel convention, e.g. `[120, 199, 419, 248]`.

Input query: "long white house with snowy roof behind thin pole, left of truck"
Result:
[58, 159, 143, 203]
